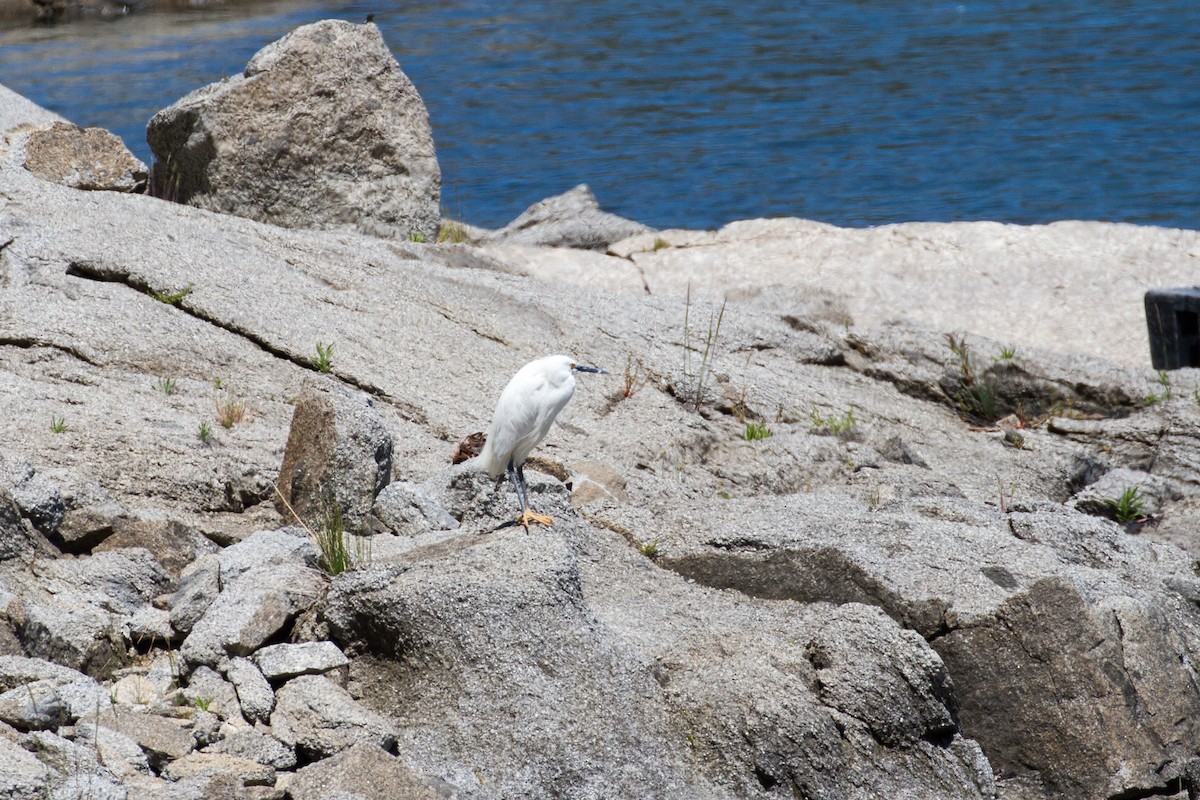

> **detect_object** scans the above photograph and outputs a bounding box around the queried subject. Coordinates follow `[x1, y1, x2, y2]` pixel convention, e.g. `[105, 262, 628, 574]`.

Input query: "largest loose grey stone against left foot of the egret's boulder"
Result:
[271, 675, 396, 760]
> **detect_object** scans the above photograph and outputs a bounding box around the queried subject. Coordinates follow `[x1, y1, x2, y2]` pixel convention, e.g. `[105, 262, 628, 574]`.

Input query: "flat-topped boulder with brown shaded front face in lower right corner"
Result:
[658, 494, 1200, 800]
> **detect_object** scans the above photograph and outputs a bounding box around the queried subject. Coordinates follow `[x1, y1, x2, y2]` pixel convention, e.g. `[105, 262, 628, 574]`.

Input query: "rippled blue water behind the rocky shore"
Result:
[0, 0, 1200, 228]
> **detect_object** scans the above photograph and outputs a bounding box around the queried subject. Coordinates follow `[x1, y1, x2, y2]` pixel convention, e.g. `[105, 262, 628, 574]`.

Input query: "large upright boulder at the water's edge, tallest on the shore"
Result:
[146, 19, 442, 241]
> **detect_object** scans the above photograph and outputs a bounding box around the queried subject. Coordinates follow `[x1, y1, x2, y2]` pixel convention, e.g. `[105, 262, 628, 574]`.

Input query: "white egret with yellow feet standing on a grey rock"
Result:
[479, 355, 608, 529]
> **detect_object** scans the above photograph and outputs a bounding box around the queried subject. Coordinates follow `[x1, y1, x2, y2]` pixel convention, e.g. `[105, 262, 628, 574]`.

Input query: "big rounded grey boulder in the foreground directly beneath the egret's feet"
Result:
[324, 522, 992, 798]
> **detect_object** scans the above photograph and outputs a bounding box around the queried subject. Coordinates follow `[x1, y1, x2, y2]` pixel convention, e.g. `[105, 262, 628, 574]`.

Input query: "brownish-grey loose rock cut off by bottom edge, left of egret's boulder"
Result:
[288, 742, 448, 800]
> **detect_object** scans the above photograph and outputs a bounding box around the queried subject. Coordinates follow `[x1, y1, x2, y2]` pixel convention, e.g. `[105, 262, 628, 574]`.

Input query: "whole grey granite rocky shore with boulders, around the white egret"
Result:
[0, 15, 1200, 800]
